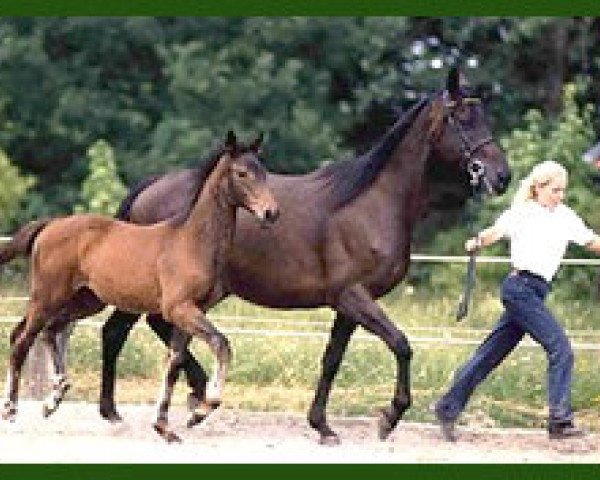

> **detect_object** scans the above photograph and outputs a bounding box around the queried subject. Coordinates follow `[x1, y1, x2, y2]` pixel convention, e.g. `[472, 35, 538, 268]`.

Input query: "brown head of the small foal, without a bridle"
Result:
[221, 131, 279, 223]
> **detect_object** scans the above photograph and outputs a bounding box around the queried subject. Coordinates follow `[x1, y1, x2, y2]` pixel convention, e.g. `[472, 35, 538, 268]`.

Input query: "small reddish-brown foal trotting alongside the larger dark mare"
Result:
[0, 132, 278, 441]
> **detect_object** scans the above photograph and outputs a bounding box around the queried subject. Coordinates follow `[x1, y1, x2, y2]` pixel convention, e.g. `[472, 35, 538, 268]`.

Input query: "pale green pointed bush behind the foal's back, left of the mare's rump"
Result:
[75, 140, 127, 216]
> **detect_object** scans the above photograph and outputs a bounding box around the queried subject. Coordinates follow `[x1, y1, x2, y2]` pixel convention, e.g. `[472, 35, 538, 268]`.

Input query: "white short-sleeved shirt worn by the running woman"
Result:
[494, 200, 595, 282]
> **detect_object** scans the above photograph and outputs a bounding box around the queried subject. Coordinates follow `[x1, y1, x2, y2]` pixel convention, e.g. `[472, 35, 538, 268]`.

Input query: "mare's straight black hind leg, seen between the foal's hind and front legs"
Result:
[100, 310, 139, 422]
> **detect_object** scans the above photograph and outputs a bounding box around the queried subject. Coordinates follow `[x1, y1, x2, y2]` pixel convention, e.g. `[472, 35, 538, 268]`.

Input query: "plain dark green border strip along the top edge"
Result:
[0, 0, 600, 16]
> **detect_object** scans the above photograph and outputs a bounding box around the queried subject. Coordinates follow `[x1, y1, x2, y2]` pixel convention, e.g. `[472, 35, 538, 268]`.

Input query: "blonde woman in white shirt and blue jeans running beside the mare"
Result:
[434, 161, 600, 441]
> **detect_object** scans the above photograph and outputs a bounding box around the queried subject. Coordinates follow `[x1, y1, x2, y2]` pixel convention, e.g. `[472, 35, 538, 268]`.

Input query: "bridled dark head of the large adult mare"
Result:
[428, 68, 511, 195]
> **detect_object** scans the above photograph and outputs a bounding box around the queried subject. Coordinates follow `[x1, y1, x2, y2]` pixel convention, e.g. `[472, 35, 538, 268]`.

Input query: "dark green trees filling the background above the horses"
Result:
[0, 17, 600, 219]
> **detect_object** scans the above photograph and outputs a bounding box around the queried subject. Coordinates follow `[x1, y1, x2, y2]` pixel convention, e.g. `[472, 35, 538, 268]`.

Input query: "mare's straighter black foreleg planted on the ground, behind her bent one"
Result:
[308, 313, 356, 445]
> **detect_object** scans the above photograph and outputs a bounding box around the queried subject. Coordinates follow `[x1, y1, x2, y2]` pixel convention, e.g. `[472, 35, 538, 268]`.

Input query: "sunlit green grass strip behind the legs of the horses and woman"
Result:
[0, 272, 600, 431]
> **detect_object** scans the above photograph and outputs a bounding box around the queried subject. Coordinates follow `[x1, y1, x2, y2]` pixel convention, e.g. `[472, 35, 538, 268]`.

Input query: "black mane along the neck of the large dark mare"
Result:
[316, 98, 429, 208]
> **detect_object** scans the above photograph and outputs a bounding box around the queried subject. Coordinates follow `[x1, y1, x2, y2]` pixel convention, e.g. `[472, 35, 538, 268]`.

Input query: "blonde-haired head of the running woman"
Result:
[513, 160, 569, 208]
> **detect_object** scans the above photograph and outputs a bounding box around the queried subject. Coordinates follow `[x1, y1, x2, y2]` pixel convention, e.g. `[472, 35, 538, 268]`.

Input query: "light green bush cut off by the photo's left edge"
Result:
[0, 150, 35, 232]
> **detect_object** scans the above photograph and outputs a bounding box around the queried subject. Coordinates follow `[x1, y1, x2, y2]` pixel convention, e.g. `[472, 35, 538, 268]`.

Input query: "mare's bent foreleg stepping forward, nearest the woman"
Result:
[335, 285, 412, 440]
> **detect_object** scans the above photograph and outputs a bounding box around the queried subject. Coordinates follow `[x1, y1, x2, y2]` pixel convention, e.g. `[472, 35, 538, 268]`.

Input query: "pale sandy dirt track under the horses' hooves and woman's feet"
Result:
[0, 402, 600, 463]
